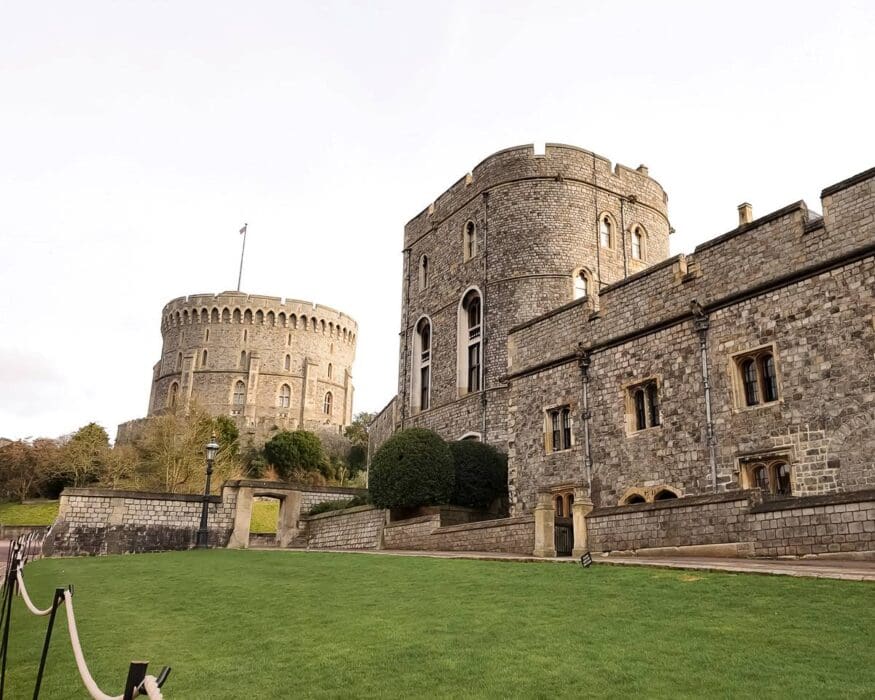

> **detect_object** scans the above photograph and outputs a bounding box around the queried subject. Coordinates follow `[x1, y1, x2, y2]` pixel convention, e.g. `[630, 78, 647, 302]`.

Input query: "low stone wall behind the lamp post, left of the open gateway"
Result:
[43, 488, 236, 556]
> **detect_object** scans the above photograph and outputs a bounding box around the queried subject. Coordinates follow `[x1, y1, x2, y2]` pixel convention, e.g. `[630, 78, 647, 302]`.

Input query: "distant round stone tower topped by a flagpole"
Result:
[119, 292, 358, 441]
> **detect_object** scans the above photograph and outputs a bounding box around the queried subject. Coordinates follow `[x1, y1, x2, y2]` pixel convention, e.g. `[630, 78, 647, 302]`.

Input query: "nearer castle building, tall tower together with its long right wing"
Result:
[371, 144, 875, 551]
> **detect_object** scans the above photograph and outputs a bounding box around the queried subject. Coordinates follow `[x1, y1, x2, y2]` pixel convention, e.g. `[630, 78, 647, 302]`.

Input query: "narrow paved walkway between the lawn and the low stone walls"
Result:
[272, 549, 875, 582]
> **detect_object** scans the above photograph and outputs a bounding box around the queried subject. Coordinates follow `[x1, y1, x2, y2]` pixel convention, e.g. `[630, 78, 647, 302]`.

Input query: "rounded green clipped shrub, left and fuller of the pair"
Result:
[368, 428, 455, 508]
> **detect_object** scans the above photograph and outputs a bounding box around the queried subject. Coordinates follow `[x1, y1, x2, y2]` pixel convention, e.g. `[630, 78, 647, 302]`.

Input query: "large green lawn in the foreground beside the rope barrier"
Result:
[7, 550, 875, 700]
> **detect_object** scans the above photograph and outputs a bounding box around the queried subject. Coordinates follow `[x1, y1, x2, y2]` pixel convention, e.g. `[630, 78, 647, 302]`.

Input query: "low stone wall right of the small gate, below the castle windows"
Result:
[586, 490, 875, 557]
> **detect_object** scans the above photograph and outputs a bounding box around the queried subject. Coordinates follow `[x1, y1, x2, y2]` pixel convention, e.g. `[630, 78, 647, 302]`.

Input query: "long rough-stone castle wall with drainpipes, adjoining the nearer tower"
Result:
[508, 165, 875, 513]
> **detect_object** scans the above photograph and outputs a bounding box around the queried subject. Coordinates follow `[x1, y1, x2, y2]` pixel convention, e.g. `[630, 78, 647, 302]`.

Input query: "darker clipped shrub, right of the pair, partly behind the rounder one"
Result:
[449, 440, 507, 509]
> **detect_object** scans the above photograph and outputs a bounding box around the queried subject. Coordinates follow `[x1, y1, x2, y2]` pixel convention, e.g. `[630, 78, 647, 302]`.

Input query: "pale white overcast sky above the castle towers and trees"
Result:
[0, 0, 875, 438]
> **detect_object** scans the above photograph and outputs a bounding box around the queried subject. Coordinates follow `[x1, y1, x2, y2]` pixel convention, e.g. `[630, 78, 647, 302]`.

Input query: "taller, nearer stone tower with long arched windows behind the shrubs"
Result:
[396, 144, 671, 447]
